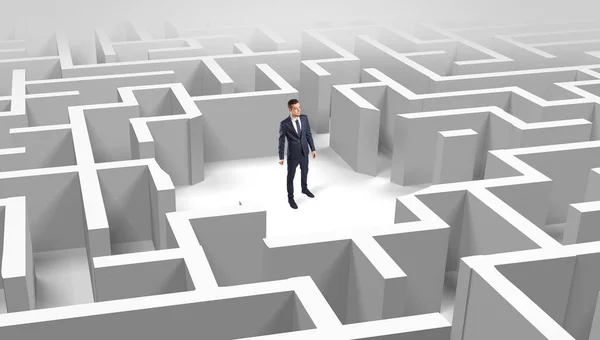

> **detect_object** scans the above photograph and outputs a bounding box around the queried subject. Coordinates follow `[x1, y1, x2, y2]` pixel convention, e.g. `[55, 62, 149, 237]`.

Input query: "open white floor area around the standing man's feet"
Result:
[176, 134, 425, 238]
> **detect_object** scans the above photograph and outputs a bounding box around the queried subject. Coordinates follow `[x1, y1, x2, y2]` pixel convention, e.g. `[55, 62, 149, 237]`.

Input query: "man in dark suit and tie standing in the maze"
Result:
[279, 99, 317, 209]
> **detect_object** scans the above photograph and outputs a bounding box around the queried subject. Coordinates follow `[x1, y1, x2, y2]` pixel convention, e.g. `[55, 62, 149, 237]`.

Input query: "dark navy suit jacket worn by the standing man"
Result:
[279, 114, 315, 159]
